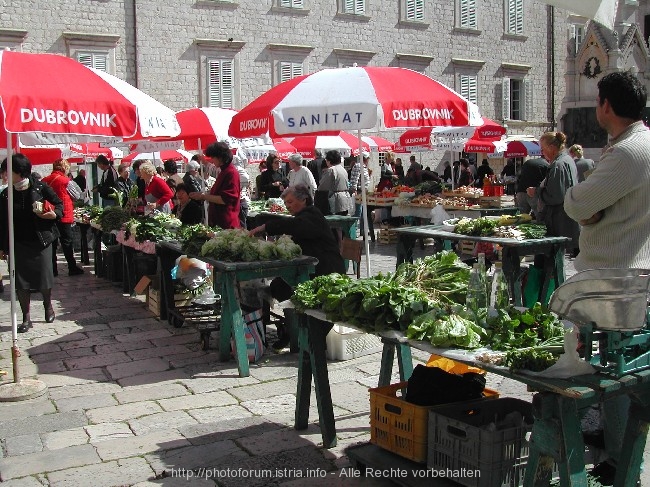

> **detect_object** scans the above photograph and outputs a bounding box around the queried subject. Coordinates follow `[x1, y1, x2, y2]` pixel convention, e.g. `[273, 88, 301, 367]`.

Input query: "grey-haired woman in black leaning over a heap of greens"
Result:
[249, 184, 345, 350]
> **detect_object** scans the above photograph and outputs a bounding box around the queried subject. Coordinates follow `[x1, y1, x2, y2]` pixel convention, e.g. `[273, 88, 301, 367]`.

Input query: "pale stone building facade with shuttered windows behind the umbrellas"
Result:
[0, 0, 572, 172]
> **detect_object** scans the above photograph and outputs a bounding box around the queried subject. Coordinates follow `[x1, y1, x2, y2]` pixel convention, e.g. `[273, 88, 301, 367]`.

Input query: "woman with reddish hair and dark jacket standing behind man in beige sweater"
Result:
[526, 132, 580, 256]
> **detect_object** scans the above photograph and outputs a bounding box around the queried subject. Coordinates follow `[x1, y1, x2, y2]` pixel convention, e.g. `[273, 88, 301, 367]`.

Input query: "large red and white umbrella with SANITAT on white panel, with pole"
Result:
[228, 66, 481, 275]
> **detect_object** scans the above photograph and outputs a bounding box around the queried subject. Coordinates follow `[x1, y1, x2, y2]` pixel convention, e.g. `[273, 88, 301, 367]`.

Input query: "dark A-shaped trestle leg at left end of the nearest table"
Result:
[295, 315, 336, 448]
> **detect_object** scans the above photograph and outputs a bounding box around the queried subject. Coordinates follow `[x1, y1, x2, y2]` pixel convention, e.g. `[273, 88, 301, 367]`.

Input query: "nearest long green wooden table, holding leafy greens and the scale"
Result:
[295, 310, 650, 487]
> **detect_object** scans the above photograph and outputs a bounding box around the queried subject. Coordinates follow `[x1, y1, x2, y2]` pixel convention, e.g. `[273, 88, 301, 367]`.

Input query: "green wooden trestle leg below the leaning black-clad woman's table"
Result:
[215, 272, 250, 377]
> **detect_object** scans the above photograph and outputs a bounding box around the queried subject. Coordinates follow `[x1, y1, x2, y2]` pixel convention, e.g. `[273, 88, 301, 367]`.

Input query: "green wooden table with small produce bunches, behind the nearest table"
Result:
[394, 225, 569, 306]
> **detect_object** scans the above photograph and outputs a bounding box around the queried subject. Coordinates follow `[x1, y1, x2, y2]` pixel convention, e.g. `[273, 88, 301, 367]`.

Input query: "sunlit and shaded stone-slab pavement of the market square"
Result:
[0, 243, 650, 487]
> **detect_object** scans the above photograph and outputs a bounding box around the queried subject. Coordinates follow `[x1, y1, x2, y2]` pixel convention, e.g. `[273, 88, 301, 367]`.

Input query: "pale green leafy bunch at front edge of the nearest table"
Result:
[406, 305, 486, 349]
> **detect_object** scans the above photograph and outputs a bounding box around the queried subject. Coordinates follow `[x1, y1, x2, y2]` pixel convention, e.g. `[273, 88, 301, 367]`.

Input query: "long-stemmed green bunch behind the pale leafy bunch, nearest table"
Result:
[393, 250, 470, 304]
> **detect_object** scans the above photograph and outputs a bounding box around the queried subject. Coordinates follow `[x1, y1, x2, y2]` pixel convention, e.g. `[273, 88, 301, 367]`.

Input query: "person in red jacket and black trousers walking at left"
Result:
[43, 159, 84, 276]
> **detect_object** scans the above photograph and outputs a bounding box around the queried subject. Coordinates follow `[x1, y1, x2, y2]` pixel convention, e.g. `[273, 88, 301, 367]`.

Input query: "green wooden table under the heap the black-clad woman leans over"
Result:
[156, 242, 318, 377]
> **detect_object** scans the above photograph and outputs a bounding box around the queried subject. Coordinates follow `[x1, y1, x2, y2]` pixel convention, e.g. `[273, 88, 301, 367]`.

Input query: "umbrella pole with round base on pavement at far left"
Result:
[0, 132, 47, 402]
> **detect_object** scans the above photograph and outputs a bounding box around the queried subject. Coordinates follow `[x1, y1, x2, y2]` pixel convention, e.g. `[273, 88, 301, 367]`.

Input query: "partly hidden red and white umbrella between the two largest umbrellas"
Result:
[157, 107, 237, 150]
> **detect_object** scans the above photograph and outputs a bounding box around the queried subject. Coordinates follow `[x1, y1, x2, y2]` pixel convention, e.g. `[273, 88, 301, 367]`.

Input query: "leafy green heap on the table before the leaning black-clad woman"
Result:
[200, 229, 302, 262]
